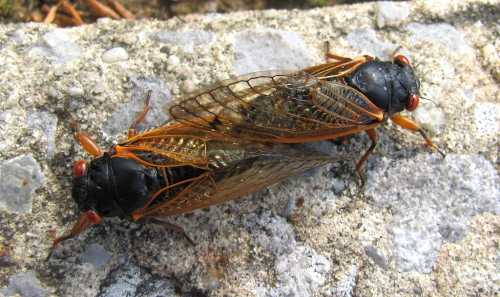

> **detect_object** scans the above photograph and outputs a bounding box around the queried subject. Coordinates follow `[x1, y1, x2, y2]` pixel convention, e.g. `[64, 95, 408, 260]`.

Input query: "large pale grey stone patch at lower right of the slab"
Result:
[366, 154, 500, 273]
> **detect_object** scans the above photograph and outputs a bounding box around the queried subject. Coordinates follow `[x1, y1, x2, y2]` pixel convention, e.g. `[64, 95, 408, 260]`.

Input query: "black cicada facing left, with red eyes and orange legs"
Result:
[53, 100, 340, 247]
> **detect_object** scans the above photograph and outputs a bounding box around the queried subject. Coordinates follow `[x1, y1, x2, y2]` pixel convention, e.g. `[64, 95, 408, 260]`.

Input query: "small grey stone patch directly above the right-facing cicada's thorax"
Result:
[347, 29, 398, 59]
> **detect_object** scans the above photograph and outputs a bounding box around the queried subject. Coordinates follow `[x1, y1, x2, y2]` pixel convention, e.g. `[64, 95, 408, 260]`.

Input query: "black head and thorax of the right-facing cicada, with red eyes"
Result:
[346, 55, 420, 115]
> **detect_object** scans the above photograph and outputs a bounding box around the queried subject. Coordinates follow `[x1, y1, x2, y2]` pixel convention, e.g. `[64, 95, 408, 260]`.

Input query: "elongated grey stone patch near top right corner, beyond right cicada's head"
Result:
[406, 23, 473, 54]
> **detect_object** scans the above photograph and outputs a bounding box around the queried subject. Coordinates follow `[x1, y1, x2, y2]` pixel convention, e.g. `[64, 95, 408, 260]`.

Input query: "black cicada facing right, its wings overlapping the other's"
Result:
[169, 50, 444, 177]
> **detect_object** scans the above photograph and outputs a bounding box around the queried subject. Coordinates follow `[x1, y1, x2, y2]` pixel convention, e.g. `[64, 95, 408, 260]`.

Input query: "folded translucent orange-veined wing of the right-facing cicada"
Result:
[169, 71, 383, 142]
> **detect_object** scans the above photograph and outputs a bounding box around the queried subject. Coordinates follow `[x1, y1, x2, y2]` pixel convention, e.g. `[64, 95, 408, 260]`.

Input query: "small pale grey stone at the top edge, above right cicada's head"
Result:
[376, 1, 410, 28]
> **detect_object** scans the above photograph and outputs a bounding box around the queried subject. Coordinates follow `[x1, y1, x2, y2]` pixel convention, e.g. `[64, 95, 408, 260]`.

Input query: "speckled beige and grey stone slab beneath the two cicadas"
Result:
[0, 0, 500, 296]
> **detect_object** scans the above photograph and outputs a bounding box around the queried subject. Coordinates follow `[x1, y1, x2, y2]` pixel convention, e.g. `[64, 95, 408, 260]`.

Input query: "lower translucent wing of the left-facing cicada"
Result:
[141, 147, 344, 216]
